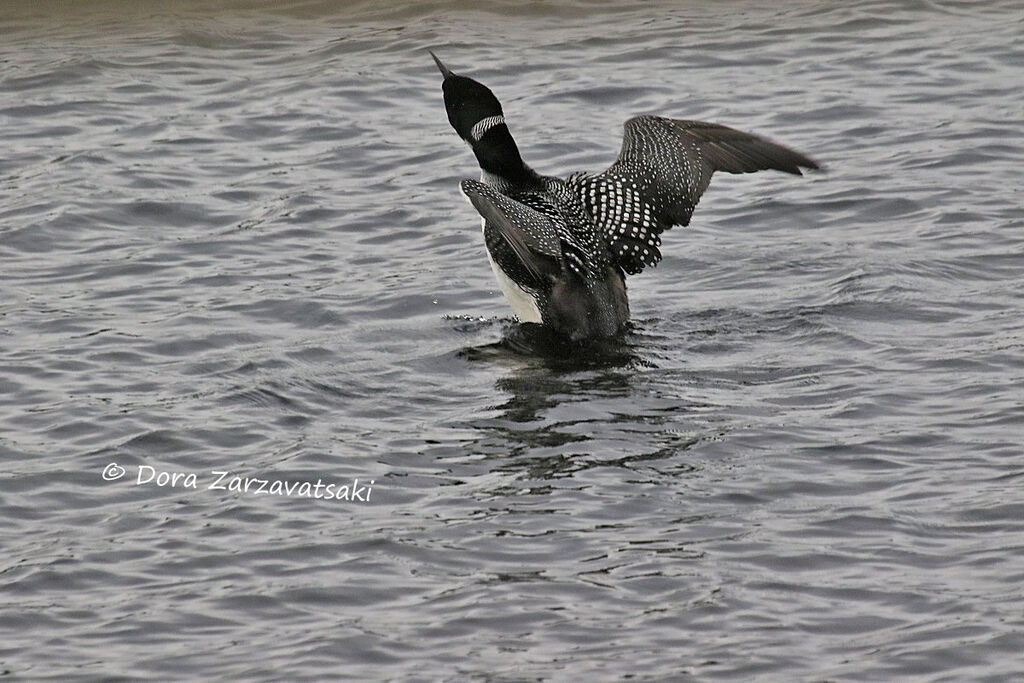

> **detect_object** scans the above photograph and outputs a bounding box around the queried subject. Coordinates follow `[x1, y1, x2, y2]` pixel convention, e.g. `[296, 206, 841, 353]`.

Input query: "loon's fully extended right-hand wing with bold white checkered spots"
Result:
[568, 116, 818, 274]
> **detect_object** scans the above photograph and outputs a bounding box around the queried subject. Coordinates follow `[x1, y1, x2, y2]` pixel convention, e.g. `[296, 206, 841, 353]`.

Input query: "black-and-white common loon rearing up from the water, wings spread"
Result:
[430, 52, 818, 341]
